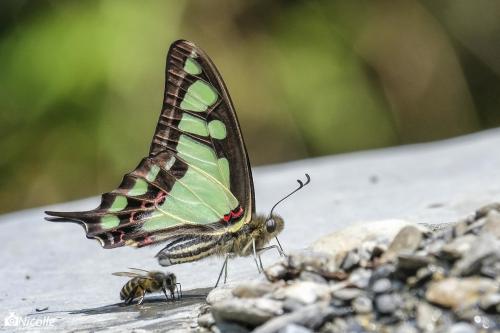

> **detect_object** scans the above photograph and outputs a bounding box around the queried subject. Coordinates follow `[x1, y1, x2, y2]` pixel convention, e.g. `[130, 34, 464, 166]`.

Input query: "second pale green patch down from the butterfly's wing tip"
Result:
[180, 80, 218, 112]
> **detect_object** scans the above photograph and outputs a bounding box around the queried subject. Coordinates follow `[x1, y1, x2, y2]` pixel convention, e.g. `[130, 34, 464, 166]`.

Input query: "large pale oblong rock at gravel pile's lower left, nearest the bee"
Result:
[212, 298, 283, 327]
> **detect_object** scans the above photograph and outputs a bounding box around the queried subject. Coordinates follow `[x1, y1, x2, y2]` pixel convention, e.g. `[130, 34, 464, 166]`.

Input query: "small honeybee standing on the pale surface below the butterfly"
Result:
[113, 268, 182, 305]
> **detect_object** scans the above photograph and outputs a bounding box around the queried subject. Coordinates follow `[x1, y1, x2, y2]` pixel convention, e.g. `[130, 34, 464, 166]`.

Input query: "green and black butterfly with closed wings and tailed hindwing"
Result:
[46, 40, 310, 279]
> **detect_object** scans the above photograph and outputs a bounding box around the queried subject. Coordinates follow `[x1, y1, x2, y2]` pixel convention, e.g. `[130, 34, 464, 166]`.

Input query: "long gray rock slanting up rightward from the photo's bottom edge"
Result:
[253, 303, 334, 333]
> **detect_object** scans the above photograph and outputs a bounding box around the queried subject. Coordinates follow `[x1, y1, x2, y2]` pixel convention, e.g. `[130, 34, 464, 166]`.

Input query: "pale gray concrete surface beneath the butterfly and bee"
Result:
[0, 130, 500, 332]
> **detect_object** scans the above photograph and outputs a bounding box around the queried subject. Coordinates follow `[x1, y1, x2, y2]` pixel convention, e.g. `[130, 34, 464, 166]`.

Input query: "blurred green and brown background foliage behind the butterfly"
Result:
[0, 0, 500, 212]
